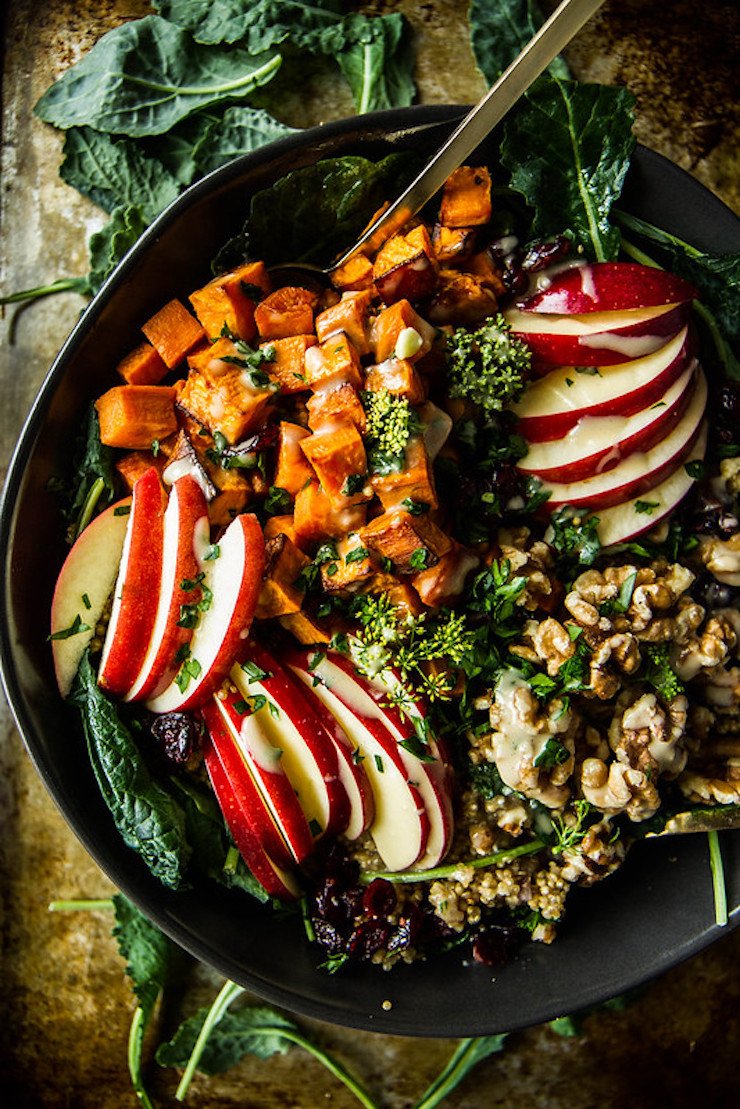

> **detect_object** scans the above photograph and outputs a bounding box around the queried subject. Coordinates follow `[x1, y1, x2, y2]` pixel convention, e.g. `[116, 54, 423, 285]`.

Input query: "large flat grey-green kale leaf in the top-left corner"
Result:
[34, 16, 281, 136]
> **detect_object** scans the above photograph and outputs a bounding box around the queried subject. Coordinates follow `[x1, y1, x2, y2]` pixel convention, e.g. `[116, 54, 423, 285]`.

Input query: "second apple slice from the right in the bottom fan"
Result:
[286, 652, 430, 871]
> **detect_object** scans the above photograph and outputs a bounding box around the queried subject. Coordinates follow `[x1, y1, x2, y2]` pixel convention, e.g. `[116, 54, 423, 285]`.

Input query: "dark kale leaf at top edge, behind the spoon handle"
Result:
[468, 0, 570, 84]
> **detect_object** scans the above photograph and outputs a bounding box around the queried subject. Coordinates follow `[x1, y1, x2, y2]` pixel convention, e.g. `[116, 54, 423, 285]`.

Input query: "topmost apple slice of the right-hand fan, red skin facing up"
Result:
[519, 262, 699, 315]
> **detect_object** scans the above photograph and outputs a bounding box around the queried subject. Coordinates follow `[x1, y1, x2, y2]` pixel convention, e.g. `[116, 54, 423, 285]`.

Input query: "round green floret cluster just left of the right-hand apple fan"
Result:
[447, 313, 531, 413]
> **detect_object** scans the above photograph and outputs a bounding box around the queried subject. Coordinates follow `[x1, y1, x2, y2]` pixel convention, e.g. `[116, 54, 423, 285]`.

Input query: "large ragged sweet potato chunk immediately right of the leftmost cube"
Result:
[179, 339, 274, 444]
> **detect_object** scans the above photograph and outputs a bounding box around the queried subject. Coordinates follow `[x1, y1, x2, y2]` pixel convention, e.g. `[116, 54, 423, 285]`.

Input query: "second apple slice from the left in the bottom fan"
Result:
[214, 690, 314, 864]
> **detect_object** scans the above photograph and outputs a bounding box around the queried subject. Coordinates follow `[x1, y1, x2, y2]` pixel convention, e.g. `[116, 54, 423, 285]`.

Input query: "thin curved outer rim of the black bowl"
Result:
[0, 105, 740, 1036]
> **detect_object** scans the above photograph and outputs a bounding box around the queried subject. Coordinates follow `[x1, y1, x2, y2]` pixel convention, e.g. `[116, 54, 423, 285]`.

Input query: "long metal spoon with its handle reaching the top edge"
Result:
[270, 0, 604, 285]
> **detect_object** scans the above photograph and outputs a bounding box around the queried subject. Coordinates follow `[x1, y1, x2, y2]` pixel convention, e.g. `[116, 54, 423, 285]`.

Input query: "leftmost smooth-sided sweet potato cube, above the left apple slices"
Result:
[95, 385, 179, 450]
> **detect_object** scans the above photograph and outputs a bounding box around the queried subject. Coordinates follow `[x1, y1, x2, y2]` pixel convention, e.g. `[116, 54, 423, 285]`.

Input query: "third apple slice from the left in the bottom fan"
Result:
[231, 642, 349, 837]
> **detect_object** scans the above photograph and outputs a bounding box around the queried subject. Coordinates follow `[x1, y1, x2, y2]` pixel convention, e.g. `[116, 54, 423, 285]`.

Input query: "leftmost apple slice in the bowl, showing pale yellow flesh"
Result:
[51, 497, 131, 698]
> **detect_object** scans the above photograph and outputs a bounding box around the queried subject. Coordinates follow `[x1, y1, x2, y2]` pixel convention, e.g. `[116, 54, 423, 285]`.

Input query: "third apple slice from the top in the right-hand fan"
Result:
[514, 327, 693, 442]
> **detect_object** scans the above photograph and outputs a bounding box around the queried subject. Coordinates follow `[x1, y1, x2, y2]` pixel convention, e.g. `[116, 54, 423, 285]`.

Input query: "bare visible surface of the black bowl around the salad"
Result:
[0, 108, 740, 1036]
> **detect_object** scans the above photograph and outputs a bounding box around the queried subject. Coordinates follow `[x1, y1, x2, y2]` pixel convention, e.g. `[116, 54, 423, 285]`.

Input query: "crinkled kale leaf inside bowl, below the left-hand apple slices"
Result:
[70, 653, 192, 889]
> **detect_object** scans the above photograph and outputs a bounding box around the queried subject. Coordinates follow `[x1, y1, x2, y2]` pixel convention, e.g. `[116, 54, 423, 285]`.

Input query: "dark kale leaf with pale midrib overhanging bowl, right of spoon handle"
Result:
[501, 78, 635, 262]
